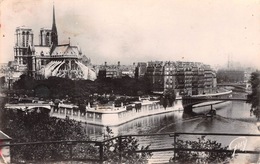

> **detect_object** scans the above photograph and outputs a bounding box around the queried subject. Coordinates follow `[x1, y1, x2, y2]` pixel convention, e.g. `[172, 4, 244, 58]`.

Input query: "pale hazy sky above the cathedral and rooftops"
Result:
[0, 0, 260, 68]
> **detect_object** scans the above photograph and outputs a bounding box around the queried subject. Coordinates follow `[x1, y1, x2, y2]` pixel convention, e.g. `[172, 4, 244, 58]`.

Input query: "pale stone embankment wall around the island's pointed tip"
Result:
[50, 100, 183, 126]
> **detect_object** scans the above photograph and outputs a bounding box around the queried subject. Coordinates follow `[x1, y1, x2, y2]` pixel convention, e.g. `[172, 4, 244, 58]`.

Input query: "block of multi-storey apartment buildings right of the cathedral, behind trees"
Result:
[145, 61, 217, 95]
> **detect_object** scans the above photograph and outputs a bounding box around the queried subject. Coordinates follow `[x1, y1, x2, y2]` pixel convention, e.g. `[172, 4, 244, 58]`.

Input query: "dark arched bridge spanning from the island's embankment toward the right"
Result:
[182, 97, 248, 113]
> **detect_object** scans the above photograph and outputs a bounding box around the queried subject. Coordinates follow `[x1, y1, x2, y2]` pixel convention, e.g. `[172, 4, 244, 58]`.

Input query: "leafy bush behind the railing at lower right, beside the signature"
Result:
[170, 136, 235, 163]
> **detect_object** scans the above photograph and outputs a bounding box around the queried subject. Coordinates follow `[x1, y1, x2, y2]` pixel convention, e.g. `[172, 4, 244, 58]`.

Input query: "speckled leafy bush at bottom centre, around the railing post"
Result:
[104, 127, 152, 164]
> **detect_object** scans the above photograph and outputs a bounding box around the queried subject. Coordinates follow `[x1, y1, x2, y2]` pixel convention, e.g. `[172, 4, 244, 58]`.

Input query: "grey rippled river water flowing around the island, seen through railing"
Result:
[85, 93, 260, 163]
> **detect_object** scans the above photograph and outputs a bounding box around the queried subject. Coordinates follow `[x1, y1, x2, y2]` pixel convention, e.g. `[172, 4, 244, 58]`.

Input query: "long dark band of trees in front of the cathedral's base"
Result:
[13, 75, 151, 105]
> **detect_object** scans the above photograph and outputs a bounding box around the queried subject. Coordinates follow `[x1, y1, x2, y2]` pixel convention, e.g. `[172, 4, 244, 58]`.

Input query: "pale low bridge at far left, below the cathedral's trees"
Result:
[5, 103, 51, 111]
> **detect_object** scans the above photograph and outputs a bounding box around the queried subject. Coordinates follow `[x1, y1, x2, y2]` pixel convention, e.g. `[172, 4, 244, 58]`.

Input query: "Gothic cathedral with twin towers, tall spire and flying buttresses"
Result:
[14, 6, 96, 80]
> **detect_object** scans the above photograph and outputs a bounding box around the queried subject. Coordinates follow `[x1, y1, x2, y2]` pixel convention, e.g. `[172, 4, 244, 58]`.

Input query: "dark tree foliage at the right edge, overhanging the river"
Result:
[247, 71, 260, 120]
